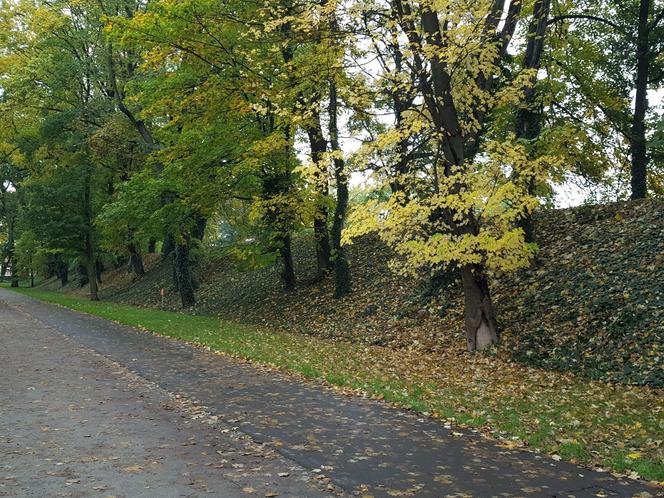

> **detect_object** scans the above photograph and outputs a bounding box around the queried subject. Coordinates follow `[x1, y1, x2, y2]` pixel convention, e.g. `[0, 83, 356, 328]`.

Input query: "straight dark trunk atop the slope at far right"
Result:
[630, 0, 652, 199]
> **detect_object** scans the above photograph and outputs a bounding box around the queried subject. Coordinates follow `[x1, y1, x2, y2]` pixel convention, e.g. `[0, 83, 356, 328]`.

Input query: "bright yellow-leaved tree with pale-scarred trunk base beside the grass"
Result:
[346, 0, 551, 351]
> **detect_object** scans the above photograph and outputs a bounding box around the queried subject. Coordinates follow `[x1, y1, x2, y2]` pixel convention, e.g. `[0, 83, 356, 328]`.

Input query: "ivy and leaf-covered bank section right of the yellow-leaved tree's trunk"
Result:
[500, 201, 664, 386]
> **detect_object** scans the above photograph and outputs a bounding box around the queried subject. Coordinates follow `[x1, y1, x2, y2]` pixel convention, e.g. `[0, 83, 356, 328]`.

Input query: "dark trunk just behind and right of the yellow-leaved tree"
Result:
[514, 0, 551, 242]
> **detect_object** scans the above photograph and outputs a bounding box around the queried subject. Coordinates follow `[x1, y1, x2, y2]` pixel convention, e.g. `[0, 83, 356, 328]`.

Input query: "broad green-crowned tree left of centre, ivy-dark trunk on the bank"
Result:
[114, 2, 330, 289]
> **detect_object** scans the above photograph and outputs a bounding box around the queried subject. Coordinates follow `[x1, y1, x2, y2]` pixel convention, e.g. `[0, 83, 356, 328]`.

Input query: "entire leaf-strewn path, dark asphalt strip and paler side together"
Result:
[0, 289, 662, 498]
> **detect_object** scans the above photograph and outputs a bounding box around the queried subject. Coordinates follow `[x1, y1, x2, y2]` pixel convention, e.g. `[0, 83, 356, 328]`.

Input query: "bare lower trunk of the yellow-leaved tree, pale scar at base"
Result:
[461, 265, 498, 351]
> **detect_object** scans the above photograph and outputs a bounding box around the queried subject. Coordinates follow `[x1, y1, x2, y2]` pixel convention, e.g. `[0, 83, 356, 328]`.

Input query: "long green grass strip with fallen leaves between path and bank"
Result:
[6, 289, 664, 481]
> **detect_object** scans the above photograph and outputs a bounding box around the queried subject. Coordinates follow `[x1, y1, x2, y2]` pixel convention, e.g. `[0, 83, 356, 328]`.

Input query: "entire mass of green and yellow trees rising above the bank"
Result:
[0, 0, 664, 350]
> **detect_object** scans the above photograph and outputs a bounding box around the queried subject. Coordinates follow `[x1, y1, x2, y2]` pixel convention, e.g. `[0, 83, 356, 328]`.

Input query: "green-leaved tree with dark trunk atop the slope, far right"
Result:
[549, 0, 664, 199]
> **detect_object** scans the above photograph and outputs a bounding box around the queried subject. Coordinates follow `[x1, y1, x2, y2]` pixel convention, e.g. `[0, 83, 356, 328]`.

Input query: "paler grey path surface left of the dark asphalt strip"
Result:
[0, 296, 329, 498]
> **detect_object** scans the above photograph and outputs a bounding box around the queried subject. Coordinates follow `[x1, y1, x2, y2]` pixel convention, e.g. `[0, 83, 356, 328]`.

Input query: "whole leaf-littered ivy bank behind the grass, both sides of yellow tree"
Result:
[89, 200, 664, 387]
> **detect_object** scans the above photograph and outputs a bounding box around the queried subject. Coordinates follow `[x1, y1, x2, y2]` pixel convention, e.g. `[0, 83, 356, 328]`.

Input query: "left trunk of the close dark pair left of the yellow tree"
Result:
[306, 109, 332, 278]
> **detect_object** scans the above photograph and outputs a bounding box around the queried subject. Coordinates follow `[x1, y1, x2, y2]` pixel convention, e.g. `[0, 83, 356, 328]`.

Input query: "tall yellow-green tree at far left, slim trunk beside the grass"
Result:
[3, 1, 118, 300]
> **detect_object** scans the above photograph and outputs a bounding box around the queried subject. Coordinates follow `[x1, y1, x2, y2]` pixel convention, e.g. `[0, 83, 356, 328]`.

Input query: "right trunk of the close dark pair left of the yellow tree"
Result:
[329, 80, 350, 299]
